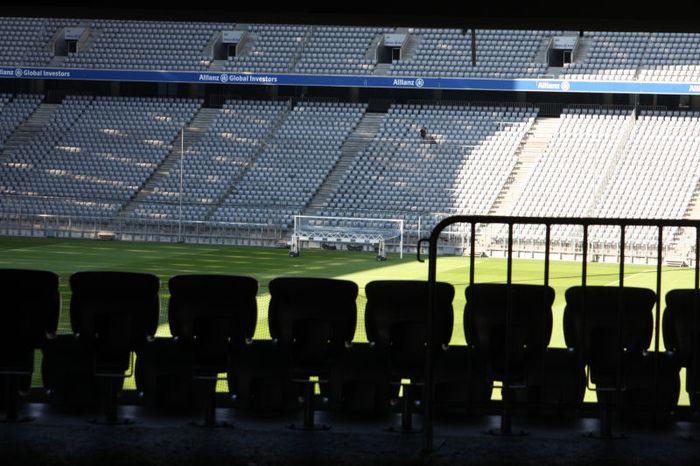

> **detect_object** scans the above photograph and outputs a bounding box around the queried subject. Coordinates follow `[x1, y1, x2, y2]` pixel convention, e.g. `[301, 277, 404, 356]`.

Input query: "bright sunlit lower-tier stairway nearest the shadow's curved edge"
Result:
[489, 117, 560, 215]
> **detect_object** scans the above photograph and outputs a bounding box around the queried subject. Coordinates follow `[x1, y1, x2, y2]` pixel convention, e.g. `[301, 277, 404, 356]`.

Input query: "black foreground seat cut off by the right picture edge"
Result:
[662, 289, 700, 411]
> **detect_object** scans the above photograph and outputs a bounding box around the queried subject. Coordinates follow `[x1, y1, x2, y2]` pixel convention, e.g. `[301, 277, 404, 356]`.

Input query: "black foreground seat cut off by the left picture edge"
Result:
[0, 269, 61, 421]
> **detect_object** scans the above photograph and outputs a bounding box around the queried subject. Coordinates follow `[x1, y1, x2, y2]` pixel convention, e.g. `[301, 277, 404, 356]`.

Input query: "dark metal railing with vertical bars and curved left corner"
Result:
[417, 216, 700, 452]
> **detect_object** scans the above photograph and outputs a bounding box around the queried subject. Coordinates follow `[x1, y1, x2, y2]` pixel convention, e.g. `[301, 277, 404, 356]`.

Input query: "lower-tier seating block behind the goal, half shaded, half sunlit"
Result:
[323, 105, 537, 229]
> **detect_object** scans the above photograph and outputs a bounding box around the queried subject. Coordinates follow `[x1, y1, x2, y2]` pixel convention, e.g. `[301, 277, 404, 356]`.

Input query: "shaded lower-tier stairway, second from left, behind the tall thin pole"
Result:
[115, 108, 221, 218]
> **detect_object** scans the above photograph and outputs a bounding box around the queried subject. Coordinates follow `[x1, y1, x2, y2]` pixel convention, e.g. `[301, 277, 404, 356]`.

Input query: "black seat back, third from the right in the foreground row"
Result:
[464, 283, 554, 378]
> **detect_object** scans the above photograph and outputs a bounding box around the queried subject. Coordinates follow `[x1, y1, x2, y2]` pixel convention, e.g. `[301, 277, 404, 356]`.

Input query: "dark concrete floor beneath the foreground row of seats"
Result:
[0, 403, 700, 466]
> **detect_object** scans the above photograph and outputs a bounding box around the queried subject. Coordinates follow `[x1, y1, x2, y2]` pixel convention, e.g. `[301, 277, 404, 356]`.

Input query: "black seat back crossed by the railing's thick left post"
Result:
[365, 280, 454, 376]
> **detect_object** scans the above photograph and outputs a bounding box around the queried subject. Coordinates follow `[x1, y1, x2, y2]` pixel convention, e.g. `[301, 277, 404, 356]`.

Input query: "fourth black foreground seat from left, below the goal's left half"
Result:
[268, 277, 358, 430]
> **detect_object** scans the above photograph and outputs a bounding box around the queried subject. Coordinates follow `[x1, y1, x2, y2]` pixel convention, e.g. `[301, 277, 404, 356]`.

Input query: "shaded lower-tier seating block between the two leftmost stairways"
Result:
[1, 96, 201, 217]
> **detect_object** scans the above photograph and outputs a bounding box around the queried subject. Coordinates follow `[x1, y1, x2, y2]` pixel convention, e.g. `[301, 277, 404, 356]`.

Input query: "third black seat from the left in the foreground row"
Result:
[168, 275, 258, 426]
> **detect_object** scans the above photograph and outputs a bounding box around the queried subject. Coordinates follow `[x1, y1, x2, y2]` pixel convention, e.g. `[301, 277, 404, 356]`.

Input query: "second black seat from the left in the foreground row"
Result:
[57, 272, 160, 424]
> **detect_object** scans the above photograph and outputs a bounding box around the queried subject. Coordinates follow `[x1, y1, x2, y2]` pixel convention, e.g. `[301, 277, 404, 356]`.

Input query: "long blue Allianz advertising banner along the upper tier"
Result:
[0, 67, 700, 95]
